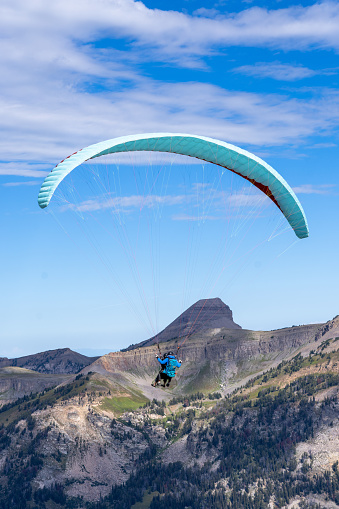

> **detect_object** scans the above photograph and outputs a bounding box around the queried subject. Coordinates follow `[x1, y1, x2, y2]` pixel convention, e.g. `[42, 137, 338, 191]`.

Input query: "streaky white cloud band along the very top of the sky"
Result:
[0, 0, 339, 69]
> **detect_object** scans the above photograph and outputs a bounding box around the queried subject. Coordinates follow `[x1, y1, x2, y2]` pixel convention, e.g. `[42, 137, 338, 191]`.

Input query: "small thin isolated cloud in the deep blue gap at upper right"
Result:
[233, 62, 317, 81]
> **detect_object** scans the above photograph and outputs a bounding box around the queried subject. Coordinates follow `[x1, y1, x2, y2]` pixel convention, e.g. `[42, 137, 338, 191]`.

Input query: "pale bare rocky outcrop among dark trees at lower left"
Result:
[32, 402, 153, 501]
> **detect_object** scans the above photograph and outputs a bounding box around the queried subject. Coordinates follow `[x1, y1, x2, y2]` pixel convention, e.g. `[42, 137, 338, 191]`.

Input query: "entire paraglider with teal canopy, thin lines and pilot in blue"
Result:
[38, 133, 309, 376]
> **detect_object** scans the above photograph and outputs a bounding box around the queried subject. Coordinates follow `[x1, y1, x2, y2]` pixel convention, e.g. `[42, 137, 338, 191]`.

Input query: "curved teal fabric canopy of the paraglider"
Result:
[38, 133, 309, 239]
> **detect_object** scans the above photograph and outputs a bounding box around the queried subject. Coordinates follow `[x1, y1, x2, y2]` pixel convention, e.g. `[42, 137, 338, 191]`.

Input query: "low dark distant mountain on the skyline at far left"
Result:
[0, 348, 98, 374]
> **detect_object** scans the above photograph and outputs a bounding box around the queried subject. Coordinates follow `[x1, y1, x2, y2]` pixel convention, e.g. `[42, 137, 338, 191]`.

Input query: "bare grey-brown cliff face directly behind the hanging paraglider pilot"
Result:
[82, 321, 326, 397]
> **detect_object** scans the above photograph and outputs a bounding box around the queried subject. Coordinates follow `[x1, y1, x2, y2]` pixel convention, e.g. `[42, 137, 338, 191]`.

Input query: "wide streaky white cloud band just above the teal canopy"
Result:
[0, 79, 339, 171]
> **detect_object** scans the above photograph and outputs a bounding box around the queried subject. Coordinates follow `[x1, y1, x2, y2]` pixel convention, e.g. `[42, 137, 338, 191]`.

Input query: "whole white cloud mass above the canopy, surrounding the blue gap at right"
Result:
[0, 0, 339, 177]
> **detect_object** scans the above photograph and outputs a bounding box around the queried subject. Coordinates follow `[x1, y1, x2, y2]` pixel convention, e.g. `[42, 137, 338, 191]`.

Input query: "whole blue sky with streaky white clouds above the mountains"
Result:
[0, 0, 339, 357]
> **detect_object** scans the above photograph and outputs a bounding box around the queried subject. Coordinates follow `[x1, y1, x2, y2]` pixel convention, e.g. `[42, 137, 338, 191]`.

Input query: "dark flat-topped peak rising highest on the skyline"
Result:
[126, 298, 241, 350]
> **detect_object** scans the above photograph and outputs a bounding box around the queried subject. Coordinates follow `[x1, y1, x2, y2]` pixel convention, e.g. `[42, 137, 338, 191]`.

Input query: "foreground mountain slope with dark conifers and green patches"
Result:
[0, 324, 339, 509]
